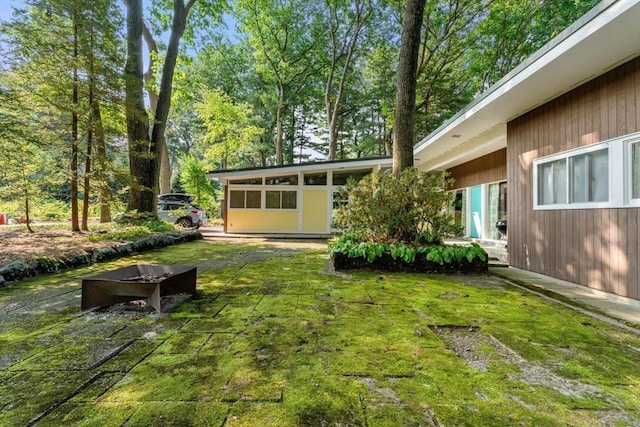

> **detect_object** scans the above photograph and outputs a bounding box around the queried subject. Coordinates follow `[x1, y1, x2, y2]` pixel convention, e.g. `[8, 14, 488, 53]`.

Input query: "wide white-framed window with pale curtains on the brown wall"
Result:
[535, 145, 609, 207]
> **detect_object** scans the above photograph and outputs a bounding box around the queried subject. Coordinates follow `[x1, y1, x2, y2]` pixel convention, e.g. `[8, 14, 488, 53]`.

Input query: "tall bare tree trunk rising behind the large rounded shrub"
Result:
[393, 0, 425, 177]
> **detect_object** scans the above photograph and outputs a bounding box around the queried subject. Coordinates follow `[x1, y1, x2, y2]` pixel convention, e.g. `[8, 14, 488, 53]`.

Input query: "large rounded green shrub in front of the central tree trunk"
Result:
[334, 168, 462, 246]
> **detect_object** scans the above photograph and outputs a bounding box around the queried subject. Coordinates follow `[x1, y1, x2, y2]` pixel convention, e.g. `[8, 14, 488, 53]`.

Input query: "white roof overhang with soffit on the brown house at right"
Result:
[414, 0, 640, 170]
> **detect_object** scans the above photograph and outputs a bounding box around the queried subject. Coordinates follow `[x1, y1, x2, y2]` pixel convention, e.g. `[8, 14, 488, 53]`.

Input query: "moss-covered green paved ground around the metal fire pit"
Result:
[0, 241, 640, 427]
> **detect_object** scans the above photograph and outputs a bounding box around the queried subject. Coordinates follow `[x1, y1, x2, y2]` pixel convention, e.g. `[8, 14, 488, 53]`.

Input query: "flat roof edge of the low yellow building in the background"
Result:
[205, 157, 392, 185]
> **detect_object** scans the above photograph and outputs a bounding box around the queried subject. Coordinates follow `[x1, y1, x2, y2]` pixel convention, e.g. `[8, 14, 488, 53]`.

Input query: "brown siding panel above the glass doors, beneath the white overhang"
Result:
[449, 148, 507, 188]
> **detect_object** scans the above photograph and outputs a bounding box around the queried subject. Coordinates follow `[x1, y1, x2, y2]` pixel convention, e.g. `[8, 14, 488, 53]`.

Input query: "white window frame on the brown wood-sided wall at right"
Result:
[533, 132, 640, 210]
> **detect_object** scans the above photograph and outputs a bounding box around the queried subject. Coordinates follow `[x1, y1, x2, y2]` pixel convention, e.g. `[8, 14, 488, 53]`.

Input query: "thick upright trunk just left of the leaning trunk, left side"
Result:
[125, 0, 158, 213]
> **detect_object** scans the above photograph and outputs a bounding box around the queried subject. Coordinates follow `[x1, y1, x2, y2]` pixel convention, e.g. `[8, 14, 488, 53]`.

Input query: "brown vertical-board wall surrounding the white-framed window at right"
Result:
[507, 58, 640, 299]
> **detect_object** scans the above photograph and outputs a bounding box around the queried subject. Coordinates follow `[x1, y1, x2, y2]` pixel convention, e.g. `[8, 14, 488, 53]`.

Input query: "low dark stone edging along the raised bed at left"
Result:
[0, 230, 203, 287]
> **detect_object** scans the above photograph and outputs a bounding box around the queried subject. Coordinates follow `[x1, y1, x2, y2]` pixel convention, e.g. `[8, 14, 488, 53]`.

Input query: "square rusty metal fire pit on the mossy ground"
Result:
[82, 264, 196, 313]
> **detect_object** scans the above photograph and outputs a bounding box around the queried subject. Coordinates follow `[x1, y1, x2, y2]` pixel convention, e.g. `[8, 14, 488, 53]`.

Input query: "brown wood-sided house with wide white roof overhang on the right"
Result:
[414, 0, 640, 299]
